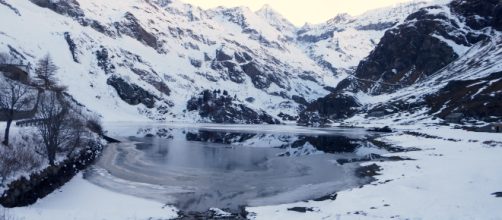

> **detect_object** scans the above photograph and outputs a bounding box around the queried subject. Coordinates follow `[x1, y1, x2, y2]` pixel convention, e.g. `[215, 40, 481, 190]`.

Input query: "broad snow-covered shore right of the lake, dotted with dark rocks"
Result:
[247, 126, 502, 220]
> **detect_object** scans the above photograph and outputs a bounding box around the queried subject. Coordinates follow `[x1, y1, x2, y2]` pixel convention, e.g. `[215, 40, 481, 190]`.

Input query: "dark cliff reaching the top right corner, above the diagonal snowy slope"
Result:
[339, 1, 498, 95]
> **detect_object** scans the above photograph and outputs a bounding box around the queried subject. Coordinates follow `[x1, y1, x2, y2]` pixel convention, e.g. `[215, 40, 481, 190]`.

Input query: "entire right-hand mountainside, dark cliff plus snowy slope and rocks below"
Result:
[299, 0, 501, 123]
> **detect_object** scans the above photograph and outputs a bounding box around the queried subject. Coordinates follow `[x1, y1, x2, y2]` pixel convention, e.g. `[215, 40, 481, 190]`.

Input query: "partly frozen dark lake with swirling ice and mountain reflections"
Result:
[86, 124, 385, 211]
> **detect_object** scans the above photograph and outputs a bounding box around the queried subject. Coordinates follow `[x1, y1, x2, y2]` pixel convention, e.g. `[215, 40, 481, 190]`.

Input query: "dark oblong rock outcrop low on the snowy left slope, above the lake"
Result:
[107, 76, 157, 108]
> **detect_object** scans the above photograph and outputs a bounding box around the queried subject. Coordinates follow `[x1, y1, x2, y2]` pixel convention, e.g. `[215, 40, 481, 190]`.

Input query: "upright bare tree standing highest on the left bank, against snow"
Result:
[35, 54, 59, 90]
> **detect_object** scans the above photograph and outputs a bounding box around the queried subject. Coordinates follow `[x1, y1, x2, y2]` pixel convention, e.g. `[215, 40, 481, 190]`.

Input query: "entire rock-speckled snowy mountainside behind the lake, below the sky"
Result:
[0, 0, 424, 121]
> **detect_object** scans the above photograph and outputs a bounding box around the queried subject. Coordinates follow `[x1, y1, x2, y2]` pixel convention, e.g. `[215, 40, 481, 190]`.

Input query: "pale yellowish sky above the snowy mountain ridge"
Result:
[182, 0, 416, 26]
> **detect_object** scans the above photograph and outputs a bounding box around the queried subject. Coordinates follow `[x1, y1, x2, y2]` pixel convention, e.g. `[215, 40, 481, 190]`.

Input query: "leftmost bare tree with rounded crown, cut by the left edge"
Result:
[0, 76, 38, 146]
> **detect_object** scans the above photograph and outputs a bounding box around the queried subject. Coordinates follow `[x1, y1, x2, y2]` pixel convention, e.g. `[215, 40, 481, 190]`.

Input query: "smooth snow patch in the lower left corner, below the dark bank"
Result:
[0, 174, 177, 220]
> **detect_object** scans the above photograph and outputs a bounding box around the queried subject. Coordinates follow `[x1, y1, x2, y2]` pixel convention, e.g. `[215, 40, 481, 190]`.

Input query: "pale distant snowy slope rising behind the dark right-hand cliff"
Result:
[297, 1, 438, 73]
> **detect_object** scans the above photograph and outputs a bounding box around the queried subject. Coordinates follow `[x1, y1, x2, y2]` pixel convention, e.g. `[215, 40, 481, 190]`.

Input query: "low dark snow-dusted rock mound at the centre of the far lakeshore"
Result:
[187, 90, 280, 124]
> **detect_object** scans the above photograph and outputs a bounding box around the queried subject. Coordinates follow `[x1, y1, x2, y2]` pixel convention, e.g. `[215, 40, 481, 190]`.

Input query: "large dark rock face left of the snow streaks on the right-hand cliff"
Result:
[338, 6, 460, 94]
